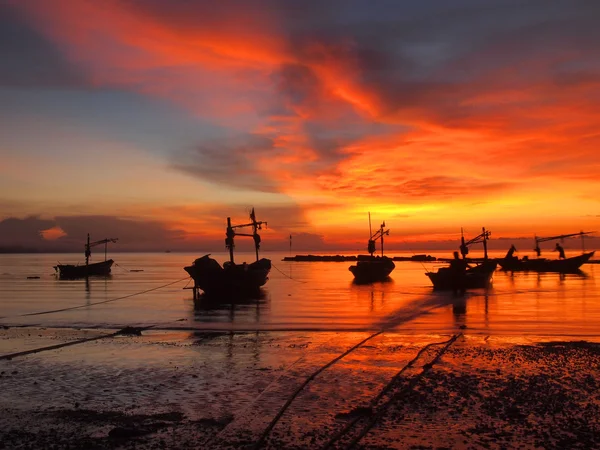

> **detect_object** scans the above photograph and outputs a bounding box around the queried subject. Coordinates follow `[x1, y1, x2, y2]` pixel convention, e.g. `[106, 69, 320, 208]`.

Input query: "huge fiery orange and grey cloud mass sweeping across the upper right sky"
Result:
[5, 0, 600, 246]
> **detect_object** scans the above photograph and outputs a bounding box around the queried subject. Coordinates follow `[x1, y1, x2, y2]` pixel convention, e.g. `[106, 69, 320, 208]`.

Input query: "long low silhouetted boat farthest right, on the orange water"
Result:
[499, 231, 595, 273]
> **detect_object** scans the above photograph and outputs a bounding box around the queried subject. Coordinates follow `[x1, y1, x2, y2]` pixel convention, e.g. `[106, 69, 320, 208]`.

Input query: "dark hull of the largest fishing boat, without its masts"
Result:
[184, 255, 271, 295]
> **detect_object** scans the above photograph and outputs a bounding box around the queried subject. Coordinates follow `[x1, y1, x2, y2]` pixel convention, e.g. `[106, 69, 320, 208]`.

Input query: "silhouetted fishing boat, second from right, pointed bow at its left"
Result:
[425, 228, 497, 292]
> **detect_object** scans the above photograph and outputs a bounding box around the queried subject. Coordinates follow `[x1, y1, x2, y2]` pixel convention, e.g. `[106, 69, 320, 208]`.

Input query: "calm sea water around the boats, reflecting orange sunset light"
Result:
[0, 251, 600, 336]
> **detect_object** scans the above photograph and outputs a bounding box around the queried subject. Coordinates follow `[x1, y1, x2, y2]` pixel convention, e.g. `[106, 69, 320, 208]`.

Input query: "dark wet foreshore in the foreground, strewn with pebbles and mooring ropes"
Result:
[0, 328, 600, 449]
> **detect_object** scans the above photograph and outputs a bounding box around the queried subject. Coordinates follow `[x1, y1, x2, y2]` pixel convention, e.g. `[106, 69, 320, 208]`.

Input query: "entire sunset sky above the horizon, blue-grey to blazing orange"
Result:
[0, 0, 600, 250]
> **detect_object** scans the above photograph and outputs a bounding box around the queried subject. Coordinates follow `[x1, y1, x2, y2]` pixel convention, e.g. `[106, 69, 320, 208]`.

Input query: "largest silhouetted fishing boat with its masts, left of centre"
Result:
[184, 208, 271, 297]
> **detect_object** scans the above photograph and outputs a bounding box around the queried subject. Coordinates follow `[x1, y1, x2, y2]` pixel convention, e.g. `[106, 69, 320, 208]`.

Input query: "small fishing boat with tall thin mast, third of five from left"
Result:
[348, 213, 396, 283]
